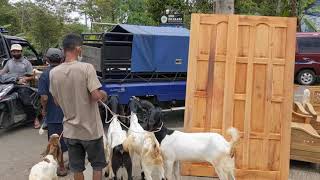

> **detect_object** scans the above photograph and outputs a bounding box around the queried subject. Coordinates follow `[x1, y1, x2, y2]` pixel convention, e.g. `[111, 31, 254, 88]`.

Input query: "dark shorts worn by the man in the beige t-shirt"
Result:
[64, 137, 107, 172]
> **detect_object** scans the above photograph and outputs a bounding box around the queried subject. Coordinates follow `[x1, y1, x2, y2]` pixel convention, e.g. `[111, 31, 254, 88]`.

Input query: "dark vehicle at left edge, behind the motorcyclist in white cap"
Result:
[0, 32, 44, 69]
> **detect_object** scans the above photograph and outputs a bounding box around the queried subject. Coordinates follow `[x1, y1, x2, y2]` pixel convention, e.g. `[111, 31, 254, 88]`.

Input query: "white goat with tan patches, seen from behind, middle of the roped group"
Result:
[123, 112, 164, 180]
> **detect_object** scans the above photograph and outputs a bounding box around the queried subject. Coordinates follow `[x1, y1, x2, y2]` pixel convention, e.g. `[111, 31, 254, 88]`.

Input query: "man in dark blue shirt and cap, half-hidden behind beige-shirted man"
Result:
[38, 48, 67, 176]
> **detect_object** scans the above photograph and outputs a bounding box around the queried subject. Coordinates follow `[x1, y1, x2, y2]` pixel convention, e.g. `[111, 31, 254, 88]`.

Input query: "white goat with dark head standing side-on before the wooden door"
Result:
[148, 109, 239, 180]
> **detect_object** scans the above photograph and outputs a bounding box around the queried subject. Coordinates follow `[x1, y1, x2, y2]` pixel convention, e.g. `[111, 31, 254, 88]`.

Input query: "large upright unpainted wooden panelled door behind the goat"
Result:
[181, 14, 296, 180]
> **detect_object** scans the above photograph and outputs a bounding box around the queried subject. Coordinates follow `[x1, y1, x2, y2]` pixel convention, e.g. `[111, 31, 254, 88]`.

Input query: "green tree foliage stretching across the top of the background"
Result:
[0, 0, 320, 51]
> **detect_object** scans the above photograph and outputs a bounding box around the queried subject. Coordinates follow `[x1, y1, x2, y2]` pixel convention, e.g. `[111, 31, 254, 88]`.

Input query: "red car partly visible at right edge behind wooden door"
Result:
[295, 32, 320, 85]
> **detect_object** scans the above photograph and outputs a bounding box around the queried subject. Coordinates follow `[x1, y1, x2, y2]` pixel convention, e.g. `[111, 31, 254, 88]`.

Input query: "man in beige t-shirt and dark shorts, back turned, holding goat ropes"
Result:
[50, 34, 107, 180]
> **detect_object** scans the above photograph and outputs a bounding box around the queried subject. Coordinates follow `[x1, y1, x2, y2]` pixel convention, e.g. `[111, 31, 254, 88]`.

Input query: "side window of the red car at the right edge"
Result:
[298, 37, 320, 53]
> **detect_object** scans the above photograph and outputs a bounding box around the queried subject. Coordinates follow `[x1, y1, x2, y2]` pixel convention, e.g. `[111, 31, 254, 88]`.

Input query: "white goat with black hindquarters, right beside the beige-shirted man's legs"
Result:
[107, 116, 132, 179]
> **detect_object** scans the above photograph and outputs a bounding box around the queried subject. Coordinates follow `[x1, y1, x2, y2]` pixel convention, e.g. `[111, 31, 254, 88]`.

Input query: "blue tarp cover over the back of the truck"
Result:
[112, 24, 189, 72]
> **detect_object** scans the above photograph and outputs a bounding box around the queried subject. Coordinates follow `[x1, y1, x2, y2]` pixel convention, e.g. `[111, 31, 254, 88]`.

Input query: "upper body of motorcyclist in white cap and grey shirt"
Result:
[0, 44, 33, 84]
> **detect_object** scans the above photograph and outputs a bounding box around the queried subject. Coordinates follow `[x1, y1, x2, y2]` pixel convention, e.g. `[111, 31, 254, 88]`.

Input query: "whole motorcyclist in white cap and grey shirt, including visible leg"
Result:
[0, 44, 40, 129]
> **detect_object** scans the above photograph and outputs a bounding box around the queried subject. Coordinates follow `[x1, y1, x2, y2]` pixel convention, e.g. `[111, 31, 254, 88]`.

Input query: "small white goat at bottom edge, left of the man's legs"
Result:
[29, 154, 58, 180]
